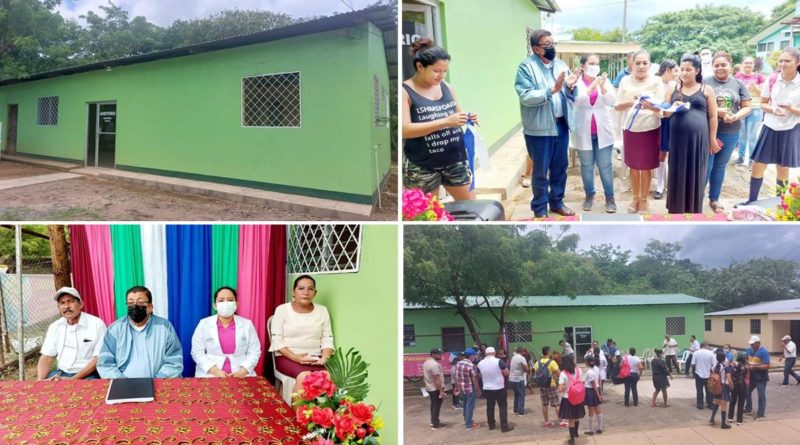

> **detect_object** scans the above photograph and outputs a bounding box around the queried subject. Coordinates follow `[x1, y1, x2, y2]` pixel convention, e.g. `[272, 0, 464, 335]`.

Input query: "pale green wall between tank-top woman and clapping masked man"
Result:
[439, 0, 541, 151]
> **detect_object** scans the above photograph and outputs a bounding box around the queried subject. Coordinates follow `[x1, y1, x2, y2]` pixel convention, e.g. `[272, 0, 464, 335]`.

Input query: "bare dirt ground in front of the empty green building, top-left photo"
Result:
[0, 162, 397, 221]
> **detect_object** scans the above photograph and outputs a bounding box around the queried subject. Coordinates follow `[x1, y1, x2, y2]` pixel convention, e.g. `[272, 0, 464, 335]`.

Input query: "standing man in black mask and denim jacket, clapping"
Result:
[514, 29, 578, 218]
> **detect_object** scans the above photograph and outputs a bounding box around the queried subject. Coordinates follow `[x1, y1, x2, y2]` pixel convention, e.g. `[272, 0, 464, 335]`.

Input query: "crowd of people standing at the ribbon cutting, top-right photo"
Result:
[402, 29, 800, 217]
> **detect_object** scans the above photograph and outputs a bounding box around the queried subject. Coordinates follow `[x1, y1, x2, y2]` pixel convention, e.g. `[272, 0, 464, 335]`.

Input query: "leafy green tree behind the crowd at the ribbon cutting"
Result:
[634, 5, 764, 63]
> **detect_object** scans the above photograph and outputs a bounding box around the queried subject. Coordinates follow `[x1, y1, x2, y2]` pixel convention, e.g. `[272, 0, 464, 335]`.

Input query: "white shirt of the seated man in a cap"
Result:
[41, 312, 106, 374]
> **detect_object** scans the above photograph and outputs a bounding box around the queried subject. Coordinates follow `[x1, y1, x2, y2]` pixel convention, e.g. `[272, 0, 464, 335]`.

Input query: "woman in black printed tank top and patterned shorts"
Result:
[402, 38, 478, 201]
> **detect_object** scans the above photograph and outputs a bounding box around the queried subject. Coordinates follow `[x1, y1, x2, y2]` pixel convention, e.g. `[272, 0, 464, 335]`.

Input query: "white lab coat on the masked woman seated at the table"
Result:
[192, 314, 261, 377]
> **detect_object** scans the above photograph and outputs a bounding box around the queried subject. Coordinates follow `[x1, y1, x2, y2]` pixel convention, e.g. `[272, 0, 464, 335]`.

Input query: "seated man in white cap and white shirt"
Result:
[36, 287, 106, 380]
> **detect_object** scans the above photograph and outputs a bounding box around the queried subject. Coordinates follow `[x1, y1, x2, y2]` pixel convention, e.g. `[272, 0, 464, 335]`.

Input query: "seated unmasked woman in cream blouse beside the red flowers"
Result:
[269, 275, 333, 392]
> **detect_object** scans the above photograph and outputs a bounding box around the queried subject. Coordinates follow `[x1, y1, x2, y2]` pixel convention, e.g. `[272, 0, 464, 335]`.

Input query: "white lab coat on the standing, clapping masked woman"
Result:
[572, 78, 617, 150]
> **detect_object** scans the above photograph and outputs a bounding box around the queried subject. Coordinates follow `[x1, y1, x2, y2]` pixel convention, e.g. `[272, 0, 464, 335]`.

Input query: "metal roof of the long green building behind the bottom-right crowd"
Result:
[405, 294, 710, 309]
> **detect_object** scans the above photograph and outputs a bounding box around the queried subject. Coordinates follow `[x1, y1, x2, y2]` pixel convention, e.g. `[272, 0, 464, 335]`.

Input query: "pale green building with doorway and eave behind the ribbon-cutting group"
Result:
[402, 0, 560, 152]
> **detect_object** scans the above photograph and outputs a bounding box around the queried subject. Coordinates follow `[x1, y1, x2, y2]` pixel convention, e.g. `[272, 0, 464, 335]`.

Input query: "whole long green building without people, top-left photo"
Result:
[0, 7, 396, 204]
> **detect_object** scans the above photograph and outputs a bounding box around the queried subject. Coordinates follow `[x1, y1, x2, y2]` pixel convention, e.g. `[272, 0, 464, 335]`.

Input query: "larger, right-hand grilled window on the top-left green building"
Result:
[242, 72, 300, 128]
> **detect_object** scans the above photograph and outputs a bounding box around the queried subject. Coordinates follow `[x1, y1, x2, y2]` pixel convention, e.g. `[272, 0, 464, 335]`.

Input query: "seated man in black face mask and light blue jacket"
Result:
[97, 286, 183, 379]
